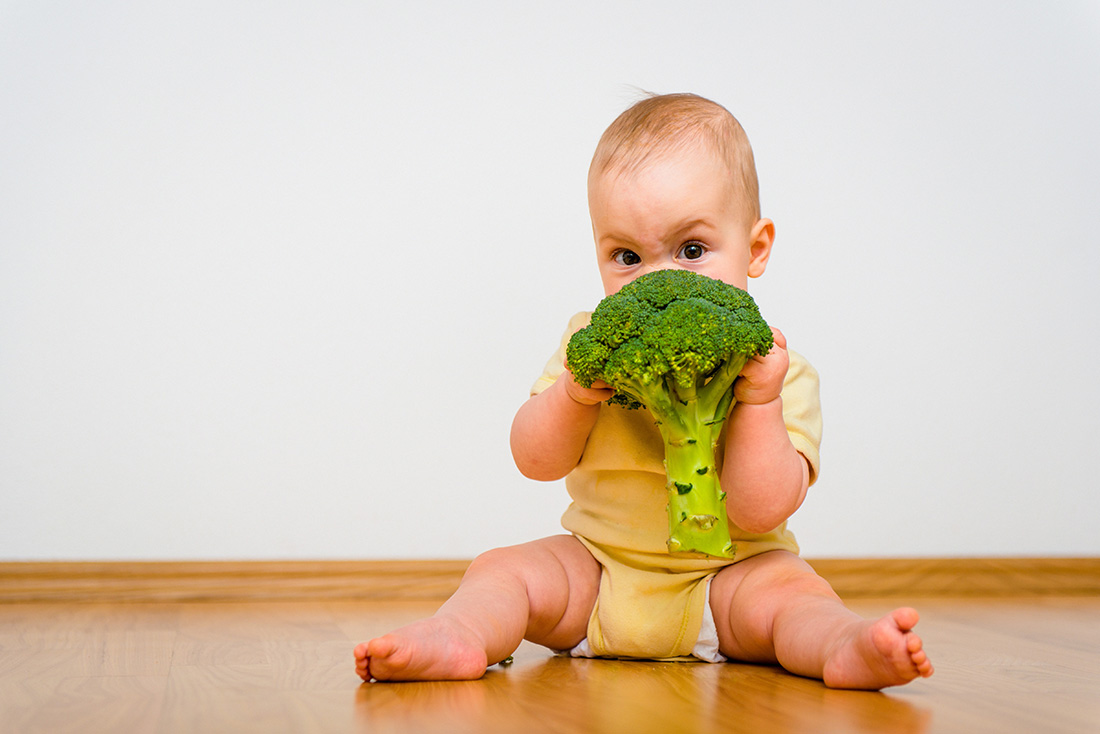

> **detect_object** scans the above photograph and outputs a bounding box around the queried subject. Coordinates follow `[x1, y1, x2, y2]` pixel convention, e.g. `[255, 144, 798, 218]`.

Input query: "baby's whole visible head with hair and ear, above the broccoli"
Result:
[589, 95, 774, 295]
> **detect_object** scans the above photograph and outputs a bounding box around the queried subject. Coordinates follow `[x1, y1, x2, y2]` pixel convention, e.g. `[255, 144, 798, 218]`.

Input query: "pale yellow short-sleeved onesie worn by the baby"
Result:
[531, 313, 822, 659]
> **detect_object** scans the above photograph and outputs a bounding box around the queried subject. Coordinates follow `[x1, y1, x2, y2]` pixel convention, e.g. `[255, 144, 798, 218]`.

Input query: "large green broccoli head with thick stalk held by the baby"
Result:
[565, 270, 772, 558]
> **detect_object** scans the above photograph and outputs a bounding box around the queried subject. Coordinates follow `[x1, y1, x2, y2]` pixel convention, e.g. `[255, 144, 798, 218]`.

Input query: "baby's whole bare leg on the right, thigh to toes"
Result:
[711, 551, 932, 690]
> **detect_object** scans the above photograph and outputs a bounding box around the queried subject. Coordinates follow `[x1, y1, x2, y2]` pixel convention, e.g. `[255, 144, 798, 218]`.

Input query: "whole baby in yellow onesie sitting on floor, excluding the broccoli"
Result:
[355, 95, 932, 689]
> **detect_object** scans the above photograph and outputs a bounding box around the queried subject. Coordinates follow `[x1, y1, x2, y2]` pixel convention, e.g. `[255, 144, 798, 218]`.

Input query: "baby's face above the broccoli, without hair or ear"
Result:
[589, 150, 756, 295]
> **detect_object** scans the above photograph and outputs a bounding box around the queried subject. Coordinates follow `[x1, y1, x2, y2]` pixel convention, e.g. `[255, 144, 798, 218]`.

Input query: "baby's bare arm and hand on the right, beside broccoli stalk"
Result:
[722, 329, 810, 533]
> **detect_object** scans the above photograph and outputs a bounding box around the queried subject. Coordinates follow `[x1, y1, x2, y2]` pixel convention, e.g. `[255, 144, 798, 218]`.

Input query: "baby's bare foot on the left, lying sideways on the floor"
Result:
[355, 617, 488, 681]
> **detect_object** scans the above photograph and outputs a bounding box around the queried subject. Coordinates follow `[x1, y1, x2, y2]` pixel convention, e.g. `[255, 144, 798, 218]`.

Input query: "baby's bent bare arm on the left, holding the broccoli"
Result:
[512, 369, 614, 481]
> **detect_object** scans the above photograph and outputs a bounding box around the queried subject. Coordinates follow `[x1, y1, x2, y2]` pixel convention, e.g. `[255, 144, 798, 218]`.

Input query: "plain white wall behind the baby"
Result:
[0, 0, 1100, 560]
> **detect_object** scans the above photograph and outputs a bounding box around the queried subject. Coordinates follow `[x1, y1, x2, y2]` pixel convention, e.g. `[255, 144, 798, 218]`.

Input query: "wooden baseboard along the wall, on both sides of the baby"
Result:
[0, 558, 1100, 603]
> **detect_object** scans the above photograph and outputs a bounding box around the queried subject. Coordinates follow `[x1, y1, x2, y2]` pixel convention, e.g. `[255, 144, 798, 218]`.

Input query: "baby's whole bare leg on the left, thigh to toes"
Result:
[355, 535, 600, 681]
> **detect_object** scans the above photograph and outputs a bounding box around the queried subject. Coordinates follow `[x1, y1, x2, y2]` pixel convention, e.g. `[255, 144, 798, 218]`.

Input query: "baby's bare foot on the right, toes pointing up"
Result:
[824, 607, 932, 690]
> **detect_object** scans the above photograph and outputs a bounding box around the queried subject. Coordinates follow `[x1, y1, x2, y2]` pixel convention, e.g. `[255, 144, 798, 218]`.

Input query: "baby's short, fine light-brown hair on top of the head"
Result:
[589, 94, 760, 224]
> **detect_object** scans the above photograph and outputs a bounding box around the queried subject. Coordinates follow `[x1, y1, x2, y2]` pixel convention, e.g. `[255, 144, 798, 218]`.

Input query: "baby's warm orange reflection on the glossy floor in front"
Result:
[354, 657, 931, 734]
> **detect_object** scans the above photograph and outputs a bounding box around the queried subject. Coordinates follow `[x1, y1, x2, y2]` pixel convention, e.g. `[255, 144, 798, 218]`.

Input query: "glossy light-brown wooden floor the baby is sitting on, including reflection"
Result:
[0, 596, 1100, 734]
